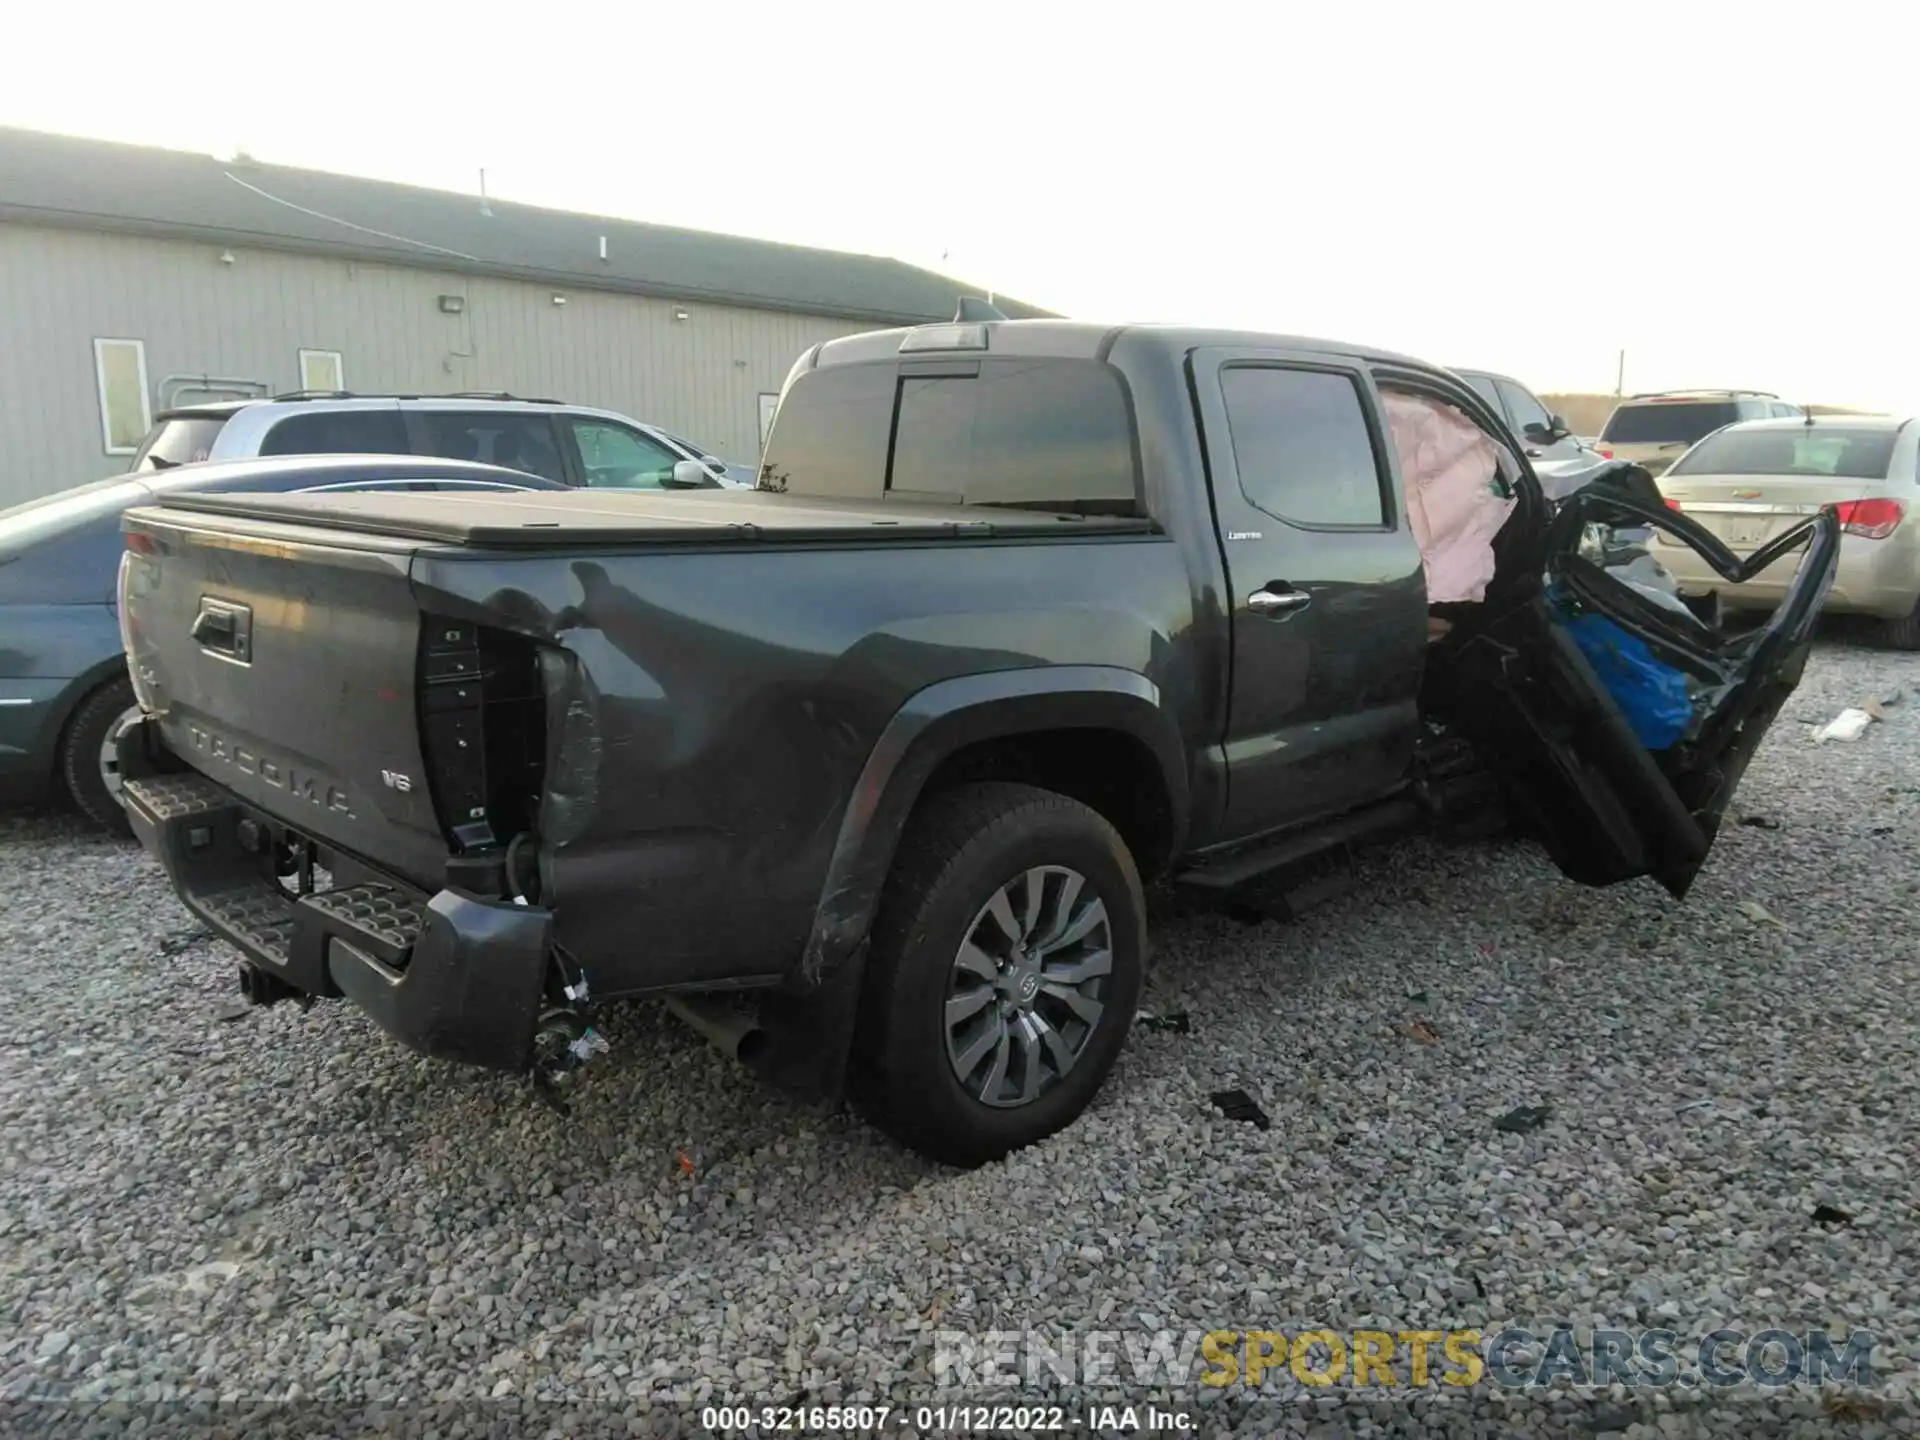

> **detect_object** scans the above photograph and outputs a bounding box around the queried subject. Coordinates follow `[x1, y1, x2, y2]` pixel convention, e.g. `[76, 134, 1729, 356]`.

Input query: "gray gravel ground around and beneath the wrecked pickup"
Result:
[0, 643, 1920, 1440]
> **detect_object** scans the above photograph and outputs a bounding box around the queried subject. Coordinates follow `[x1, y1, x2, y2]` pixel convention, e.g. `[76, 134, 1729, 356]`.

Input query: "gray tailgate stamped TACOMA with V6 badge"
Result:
[121, 511, 447, 883]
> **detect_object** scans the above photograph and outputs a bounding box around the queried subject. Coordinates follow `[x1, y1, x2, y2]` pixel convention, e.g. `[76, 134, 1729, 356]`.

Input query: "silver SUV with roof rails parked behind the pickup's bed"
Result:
[132, 392, 756, 490]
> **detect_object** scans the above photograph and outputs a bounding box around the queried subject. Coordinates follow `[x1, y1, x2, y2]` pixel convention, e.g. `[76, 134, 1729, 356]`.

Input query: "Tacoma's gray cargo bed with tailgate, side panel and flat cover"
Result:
[112, 480, 1212, 995]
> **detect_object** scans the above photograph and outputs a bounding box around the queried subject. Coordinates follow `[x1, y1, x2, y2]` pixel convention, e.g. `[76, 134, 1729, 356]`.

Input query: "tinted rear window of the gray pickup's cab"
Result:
[760, 355, 1142, 516]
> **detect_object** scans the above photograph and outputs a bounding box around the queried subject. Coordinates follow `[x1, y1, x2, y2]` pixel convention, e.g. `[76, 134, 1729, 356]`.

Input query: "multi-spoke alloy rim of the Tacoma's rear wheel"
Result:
[945, 866, 1114, 1110]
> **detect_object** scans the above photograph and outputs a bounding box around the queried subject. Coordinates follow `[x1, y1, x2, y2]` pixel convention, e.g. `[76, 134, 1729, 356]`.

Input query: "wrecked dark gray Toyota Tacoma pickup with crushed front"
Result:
[121, 318, 1839, 1164]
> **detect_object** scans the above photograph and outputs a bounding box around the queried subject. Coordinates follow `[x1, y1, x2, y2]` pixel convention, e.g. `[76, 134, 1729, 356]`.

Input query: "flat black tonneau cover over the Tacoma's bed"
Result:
[129, 490, 1158, 549]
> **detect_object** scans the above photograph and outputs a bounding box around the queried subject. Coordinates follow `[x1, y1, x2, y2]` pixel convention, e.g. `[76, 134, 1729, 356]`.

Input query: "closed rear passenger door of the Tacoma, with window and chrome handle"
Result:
[1190, 348, 1427, 841]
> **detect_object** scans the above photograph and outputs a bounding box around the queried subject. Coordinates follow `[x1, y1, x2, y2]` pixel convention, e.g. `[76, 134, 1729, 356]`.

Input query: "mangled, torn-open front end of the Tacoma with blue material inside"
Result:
[1423, 465, 1839, 897]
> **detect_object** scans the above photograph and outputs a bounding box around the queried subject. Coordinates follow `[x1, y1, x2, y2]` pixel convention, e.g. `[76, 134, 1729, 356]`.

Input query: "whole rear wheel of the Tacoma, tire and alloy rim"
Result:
[851, 783, 1146, 1165]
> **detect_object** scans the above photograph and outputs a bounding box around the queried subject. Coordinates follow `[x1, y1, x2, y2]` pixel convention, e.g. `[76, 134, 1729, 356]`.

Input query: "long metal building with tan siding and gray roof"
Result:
[0, 129, 1044, 509]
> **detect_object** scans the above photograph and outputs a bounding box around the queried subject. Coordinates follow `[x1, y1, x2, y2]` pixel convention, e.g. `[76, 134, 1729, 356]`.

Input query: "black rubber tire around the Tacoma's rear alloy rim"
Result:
[849, 783, 1146, 1165]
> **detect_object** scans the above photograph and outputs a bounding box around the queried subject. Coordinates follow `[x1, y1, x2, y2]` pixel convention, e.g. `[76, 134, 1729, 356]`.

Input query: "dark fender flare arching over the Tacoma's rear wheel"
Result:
[801, 664, 1190, 985]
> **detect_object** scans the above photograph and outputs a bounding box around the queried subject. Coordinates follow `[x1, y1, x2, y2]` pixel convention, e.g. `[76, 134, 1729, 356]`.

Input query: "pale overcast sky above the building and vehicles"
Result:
[0, 0, 1920, 407]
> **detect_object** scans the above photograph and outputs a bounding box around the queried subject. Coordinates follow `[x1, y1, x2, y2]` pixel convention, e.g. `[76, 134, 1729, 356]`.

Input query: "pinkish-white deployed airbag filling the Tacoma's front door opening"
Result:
[1382, 390, 1513, 605]
